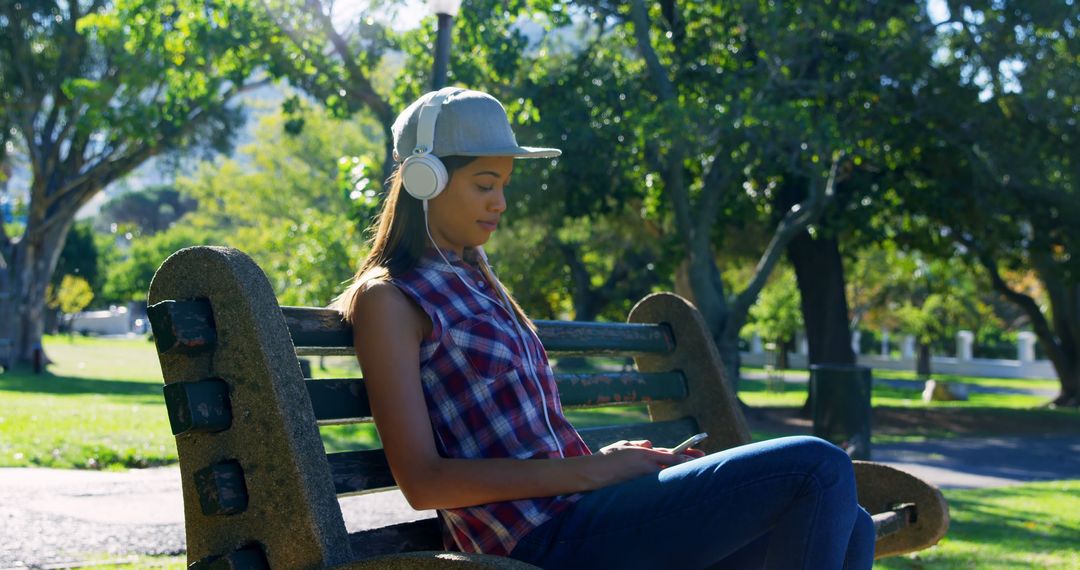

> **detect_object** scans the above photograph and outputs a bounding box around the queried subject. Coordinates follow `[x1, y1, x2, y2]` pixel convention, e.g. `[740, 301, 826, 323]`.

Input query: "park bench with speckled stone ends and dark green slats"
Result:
[149, 247, 948, 569]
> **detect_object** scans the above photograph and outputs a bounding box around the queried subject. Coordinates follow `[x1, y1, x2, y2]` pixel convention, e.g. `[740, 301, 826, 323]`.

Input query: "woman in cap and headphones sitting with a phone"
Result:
[336, 89, 874, 569]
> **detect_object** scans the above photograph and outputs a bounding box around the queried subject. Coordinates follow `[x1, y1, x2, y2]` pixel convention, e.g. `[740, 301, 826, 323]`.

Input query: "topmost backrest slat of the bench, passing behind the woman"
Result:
[281, 307, 675, 356]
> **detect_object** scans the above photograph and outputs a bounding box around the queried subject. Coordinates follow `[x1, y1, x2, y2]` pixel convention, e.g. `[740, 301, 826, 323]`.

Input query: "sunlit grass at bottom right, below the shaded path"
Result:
[875, 480, 1080, 570]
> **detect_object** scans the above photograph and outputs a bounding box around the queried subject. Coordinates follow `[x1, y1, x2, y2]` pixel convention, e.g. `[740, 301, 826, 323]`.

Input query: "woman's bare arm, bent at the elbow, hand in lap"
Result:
[353, 282, 687, 510]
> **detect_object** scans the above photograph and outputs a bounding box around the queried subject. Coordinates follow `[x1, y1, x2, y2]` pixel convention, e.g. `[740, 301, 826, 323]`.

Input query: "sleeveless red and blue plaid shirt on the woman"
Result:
[391, 248, 590, 555]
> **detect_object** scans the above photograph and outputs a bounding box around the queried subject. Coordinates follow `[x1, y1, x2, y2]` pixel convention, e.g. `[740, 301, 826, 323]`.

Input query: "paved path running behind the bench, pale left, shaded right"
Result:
[0, 436, 1080, 569]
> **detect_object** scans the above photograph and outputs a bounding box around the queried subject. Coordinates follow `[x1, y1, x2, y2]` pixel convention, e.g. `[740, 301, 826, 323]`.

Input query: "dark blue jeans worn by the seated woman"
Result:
[510, 436, 875, 570]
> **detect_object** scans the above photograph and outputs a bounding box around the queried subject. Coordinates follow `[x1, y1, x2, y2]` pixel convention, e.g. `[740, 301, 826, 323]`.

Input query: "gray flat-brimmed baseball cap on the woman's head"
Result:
[391, 87, 563, 162]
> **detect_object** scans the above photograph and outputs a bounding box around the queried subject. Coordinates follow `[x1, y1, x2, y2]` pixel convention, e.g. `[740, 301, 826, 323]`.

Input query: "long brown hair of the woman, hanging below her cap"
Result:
[330, 157, 536, 330]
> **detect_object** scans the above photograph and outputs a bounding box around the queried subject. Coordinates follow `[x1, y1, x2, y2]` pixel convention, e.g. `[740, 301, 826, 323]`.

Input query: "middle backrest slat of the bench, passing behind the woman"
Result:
[305, 371, 687, 425]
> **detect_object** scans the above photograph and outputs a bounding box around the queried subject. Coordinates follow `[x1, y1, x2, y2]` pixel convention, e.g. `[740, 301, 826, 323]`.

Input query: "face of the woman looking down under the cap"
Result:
[428, 157, 514, 255]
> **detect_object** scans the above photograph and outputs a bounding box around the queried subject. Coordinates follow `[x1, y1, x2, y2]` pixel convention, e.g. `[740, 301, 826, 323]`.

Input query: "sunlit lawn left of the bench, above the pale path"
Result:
[0, 337, 176, 469]
